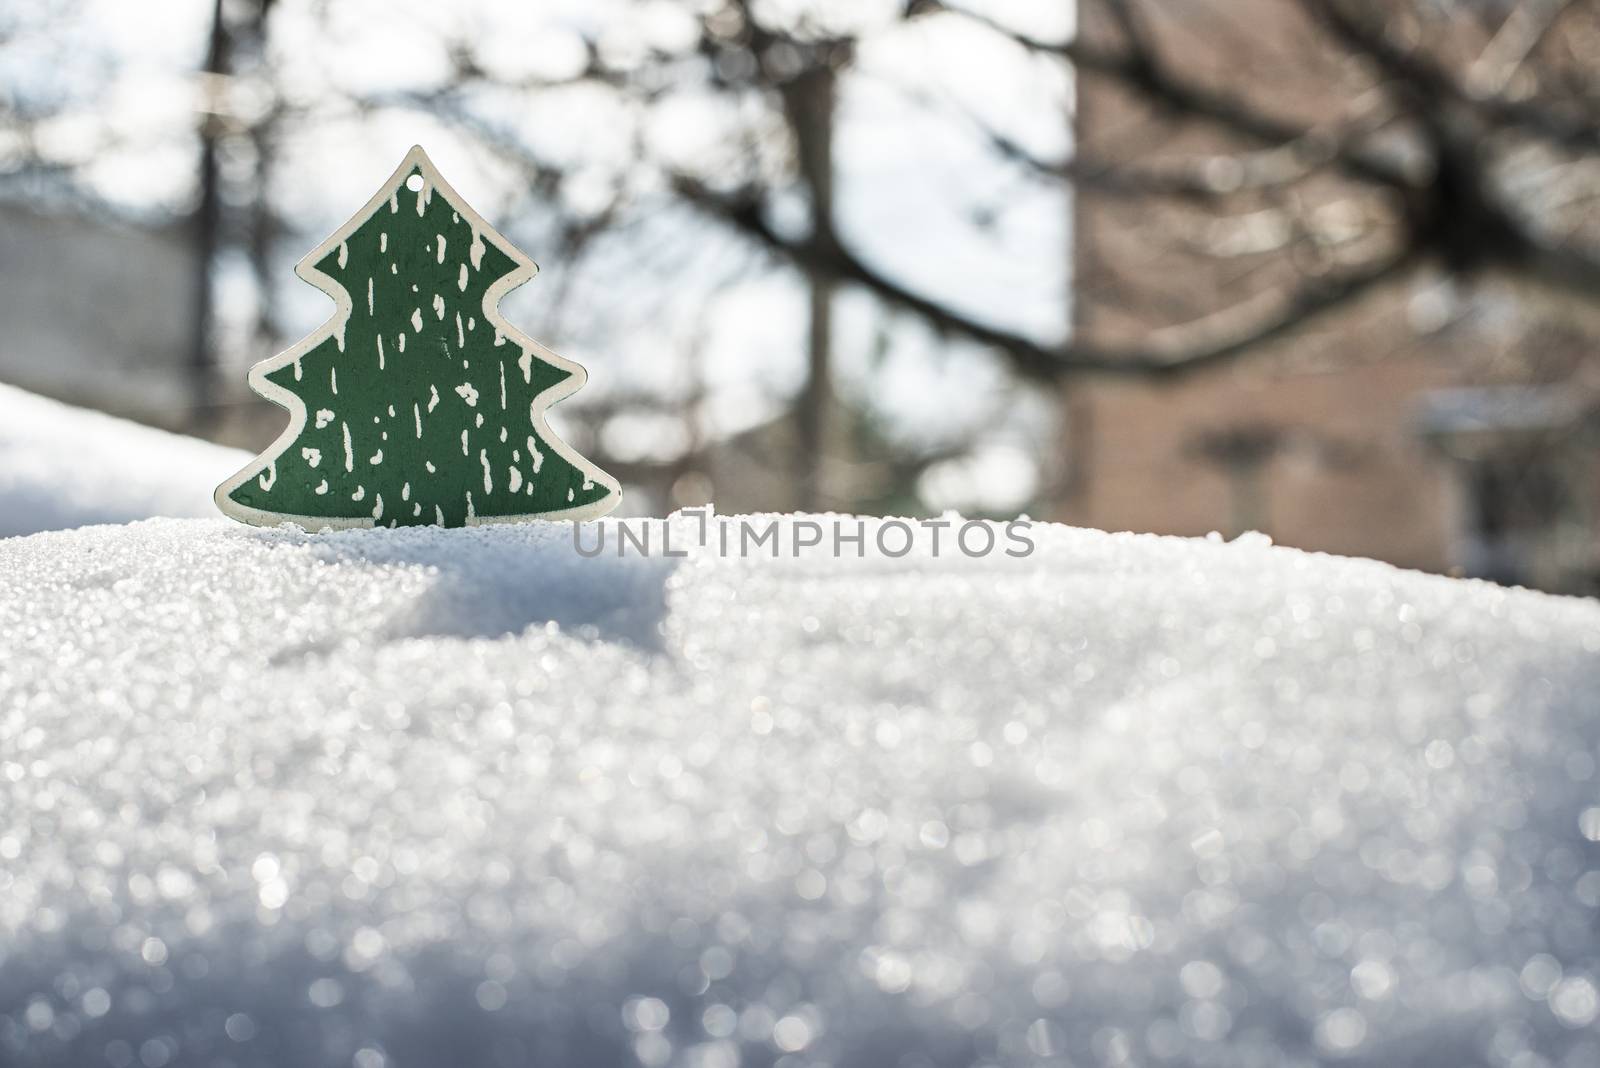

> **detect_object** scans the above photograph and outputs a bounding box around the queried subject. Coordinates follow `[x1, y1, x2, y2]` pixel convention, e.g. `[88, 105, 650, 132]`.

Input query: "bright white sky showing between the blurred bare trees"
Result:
[0, 0, 1072, 513]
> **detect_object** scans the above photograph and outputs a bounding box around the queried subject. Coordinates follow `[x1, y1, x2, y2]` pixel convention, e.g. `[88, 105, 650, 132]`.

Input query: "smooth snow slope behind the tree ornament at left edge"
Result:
[0, 384, 250, 537]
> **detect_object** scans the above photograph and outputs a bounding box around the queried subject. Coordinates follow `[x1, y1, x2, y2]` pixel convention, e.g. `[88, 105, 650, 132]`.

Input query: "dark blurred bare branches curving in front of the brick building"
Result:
[374, 0, 1600, 388]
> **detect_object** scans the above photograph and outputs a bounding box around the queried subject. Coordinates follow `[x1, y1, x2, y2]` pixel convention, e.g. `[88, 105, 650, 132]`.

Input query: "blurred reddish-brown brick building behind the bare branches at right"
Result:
[1058, 0, 1600, 592]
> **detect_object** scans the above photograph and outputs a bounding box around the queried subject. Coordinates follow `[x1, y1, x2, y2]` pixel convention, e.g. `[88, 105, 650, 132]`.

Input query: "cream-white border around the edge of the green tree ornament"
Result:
[213, 144, 622, 531]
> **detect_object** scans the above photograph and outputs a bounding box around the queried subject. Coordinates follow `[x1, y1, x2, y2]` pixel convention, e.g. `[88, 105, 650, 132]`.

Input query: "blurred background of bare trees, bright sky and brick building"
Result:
[12, 0, 1600, 593]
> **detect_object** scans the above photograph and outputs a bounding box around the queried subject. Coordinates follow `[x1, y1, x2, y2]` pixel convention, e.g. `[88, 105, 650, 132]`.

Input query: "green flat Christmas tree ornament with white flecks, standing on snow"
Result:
[216, 147, 621, 531]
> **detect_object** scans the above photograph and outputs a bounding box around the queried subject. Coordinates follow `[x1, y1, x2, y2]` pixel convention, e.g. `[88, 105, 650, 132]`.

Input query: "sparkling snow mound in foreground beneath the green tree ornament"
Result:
[0, 511, 1600, 1068]
